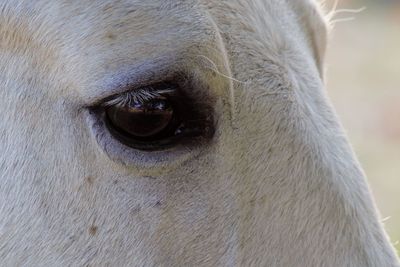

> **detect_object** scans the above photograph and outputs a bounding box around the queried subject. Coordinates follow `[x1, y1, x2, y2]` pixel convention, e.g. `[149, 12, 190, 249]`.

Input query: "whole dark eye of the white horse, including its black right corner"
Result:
[103, 83, 214, 150]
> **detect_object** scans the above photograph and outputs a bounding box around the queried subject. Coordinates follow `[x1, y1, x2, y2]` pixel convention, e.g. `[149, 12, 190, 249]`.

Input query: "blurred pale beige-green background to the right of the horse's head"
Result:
[324, 0, 400, 255]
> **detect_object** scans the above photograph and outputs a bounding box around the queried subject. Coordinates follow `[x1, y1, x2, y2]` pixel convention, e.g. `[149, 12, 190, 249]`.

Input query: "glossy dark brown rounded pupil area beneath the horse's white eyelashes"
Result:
[106, 97, 173, 138]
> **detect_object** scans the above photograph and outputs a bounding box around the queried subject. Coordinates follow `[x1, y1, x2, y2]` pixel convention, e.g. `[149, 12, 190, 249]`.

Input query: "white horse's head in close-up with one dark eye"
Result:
[0, 0, 399, 267]
